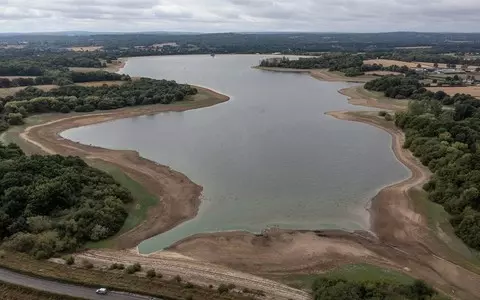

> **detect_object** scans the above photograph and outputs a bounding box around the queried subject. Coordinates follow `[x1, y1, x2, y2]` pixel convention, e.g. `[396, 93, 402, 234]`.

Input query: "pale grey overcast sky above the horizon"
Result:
[0, 0, 480, 32]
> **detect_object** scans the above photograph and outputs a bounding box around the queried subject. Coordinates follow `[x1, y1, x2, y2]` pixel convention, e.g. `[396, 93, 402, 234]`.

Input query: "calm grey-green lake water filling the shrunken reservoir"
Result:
[62, 55, 409, 253]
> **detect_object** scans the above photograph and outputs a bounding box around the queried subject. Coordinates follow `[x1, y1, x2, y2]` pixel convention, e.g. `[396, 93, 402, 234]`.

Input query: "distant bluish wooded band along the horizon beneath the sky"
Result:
[4, 32, 480, 54]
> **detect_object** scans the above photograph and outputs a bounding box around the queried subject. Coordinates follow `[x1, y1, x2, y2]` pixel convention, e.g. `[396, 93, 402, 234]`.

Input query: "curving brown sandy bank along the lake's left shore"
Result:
[20, 88, 229, 248]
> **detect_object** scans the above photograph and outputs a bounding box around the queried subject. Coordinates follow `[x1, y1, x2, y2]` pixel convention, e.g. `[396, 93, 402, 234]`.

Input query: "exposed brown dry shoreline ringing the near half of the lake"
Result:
[14, 67, 480, 299]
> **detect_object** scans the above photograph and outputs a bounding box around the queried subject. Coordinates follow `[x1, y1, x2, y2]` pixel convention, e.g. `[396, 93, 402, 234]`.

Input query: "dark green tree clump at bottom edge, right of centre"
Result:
[312, 278, 446, 300]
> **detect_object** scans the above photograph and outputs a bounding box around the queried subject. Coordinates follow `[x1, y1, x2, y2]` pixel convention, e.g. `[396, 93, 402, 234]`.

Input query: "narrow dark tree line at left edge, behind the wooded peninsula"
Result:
[0, 70, 131, 88]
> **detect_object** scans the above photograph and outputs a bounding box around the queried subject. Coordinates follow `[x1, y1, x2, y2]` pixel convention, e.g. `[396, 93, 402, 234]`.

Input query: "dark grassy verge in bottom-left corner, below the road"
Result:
[0, 281, 83, 300]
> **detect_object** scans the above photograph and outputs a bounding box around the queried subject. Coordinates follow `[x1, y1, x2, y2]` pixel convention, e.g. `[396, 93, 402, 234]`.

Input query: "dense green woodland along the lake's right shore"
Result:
[365, 76, 480, 249]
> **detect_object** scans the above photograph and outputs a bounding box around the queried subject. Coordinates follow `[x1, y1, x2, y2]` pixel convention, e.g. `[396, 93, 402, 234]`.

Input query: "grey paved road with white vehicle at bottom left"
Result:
[0, 269, 156, 300]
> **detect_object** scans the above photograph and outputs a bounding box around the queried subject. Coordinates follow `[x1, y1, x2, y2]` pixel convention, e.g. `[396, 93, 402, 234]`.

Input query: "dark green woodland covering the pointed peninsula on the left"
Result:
[0, 78, 197, 131]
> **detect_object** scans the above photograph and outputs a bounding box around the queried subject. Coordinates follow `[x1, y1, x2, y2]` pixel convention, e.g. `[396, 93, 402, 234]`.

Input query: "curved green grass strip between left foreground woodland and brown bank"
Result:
[86, 161, 159, 248]
